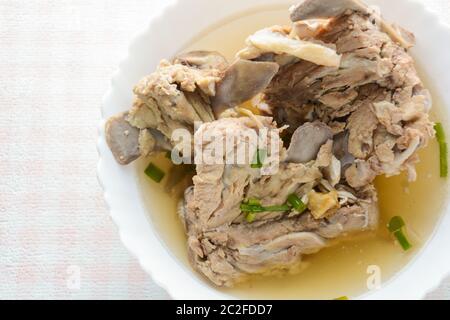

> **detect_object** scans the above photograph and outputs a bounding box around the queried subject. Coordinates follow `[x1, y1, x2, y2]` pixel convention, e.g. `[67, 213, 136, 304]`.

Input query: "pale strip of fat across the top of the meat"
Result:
[247, 29, 341, 67]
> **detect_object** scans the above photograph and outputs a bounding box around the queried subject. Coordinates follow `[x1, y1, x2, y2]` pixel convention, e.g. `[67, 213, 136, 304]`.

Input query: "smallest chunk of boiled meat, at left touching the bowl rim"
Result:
[106, 51, 228, 164]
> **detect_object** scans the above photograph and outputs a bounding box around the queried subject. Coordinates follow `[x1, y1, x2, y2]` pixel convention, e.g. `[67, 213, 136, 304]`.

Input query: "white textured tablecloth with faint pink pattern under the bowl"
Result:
[0, 0, 450, 299]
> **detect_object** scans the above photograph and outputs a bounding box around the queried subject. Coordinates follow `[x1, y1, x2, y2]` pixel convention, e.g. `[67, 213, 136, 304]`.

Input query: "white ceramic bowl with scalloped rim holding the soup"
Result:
[98, 0, 450, 299]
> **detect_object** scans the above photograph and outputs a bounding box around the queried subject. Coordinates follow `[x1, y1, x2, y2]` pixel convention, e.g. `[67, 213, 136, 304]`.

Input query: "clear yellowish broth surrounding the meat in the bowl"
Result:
[136, 6, 448, 299]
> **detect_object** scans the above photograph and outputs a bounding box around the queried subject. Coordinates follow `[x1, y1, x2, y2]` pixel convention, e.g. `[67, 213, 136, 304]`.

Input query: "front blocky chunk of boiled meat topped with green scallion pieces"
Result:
[179, 117, 378, 286]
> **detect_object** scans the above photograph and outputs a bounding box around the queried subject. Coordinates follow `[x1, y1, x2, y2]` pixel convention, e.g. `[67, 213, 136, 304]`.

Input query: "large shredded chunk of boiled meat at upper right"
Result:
[264, 8, 434, 188]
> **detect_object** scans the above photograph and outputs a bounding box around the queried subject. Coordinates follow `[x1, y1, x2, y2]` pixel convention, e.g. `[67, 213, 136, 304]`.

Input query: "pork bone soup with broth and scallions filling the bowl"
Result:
[107, 0, 448, 299]
